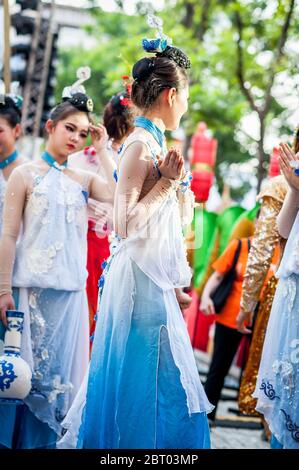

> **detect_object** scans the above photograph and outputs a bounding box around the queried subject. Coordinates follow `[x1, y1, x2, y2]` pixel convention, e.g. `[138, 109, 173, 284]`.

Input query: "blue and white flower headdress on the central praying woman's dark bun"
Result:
[133, 15, 191, 81]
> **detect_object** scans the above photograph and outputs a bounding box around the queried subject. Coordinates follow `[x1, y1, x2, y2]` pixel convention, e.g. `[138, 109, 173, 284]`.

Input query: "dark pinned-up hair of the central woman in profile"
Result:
[132, 47, 190, 109]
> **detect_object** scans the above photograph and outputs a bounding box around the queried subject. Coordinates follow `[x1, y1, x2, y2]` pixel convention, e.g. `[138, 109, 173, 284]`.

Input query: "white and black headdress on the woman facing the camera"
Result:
[62, 67, 93, 112]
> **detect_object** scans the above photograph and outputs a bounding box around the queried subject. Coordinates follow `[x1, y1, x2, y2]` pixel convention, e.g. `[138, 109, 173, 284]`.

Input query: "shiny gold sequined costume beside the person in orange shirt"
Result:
[239, 176, 288, 415]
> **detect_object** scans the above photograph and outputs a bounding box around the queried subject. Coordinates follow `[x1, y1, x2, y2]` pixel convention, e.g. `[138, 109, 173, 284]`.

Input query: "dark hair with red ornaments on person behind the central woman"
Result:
[103, 91, 135, 141]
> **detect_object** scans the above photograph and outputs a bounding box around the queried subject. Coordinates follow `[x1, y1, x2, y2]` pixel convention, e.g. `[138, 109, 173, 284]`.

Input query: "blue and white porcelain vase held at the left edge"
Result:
[0, 310, 32, 403]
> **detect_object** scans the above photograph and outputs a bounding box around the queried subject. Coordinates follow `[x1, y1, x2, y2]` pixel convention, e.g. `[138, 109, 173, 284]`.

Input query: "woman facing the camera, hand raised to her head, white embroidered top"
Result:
[0, 83, 115, 448]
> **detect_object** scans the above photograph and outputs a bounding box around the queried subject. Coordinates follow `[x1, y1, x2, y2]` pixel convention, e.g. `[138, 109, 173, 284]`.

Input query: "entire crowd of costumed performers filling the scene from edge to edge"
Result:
[0, 16, 299, 449]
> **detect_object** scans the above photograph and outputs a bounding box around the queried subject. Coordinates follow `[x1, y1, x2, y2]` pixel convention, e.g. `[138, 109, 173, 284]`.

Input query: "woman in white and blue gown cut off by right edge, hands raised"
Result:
[253, 142, 299, 449]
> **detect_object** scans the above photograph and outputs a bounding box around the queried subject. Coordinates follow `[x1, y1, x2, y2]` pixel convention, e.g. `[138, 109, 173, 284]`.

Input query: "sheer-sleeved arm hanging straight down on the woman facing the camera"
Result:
[0, 168, 27, 325]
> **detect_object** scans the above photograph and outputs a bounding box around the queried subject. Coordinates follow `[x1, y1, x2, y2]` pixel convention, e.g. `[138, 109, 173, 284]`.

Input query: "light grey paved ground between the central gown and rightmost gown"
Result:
[195, 351, 270, 449]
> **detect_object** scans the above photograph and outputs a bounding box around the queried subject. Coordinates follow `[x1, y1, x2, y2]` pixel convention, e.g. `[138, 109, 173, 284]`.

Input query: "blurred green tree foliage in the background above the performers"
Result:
[57, 0, 299, 195]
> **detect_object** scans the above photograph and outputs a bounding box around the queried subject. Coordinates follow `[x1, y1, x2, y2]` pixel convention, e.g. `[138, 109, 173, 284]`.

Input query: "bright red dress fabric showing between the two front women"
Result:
[86, 222, 110, 346]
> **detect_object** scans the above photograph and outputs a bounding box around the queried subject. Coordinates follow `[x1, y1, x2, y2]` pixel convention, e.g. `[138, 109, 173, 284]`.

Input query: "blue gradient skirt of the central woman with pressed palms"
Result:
[77, 263, 210, 449]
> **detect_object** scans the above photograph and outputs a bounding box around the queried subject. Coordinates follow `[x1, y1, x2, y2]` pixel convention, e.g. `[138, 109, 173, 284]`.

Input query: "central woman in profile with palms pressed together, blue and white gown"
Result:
[58, 24, 213, 449]
